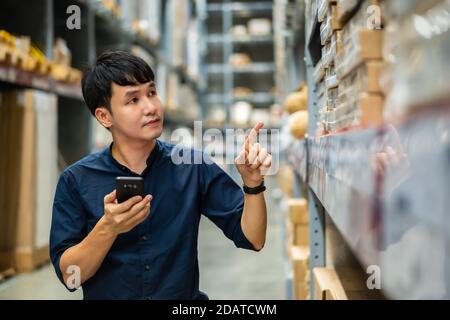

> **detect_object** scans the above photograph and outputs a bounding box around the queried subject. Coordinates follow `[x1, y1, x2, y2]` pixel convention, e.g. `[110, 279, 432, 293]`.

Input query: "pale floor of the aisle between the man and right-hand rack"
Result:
[199, 179, 285, 300]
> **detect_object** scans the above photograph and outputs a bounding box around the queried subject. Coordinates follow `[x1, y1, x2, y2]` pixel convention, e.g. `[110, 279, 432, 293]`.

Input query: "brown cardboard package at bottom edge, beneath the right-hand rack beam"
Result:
[313, 267, 383, 300]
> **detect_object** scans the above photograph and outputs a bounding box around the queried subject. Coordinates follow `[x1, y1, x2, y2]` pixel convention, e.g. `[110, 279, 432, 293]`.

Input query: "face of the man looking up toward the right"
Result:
[103, 82, 164, 141]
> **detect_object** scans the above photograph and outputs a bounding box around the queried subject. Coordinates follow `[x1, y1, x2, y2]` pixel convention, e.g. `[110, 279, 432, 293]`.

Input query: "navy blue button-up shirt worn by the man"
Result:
[50, 140, 255, 299]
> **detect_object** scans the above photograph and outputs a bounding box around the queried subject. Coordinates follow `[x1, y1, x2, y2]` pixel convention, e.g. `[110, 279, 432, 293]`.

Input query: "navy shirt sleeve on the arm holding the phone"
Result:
[50, 171, 87, 291]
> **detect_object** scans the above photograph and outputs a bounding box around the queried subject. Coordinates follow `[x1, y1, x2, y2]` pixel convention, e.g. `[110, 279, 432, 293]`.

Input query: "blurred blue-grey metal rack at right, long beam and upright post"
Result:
[282, 0, 450, 299]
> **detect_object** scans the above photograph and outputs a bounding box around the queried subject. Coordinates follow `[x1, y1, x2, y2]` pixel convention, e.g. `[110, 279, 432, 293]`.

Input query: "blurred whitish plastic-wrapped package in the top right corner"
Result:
[382, 1, 450, 119]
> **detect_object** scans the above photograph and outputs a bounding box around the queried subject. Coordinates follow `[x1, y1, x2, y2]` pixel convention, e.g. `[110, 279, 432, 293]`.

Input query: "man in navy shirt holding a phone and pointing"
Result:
[50, 52, 271, 299]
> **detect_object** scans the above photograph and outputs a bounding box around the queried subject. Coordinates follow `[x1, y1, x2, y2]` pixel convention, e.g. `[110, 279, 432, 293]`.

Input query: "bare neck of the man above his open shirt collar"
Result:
[112, 139, 156, 174]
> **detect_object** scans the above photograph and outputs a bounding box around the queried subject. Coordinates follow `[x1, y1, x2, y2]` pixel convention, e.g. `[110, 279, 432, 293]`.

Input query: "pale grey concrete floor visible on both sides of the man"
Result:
[0, 184, 285, 300]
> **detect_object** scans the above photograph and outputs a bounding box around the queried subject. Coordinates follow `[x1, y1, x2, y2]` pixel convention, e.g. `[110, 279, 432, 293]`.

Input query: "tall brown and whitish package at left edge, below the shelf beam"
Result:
[0, 90, 58, 272]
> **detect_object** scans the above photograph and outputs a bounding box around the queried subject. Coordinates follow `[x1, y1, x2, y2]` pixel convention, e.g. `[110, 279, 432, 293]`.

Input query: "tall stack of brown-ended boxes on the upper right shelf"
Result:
[323, 0, 384, 133]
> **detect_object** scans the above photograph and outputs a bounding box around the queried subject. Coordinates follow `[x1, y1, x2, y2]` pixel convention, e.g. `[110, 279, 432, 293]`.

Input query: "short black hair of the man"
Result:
[81, 51, 155, 115]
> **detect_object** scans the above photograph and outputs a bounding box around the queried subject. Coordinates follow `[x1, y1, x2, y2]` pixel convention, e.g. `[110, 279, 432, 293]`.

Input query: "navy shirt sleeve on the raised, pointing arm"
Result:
[200, 156, 259, 251]
